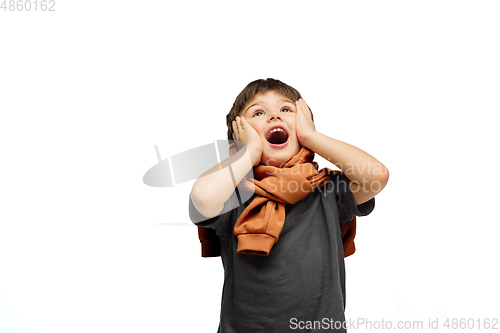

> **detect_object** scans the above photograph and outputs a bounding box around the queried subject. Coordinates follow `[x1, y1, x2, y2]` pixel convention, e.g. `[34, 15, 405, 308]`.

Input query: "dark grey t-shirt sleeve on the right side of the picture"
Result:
[330, 172, 375, 223]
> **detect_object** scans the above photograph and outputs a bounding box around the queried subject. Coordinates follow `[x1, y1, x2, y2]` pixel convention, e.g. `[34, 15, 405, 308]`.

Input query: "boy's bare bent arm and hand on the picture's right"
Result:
[296, 99, 389, 205]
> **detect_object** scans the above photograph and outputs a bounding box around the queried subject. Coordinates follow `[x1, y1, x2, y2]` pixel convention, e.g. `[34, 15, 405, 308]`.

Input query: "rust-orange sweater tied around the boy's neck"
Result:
[198, 147, 356, 257]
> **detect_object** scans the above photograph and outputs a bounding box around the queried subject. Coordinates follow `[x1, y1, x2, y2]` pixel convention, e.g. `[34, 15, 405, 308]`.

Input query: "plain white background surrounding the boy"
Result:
[0, 0, 500, 333]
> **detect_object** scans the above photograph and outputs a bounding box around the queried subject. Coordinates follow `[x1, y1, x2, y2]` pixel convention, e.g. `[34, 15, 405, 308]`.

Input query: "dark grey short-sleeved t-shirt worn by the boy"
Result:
[189, 172, 375, 333]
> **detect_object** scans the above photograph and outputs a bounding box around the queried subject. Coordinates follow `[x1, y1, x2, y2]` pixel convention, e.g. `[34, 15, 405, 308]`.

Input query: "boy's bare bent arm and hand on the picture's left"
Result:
[191, 117, 262, 218]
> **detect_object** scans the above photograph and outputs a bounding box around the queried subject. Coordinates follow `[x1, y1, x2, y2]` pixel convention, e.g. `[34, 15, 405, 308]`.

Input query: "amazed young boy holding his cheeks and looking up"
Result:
[190, 79, 389, 333]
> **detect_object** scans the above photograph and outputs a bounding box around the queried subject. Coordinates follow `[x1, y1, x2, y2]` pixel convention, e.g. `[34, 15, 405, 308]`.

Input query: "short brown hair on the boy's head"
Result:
[226, 78, 314, 140]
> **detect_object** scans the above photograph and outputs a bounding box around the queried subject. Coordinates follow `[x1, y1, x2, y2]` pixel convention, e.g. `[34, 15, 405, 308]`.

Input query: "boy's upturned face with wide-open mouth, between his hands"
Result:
[240, 91, 301, 167]
